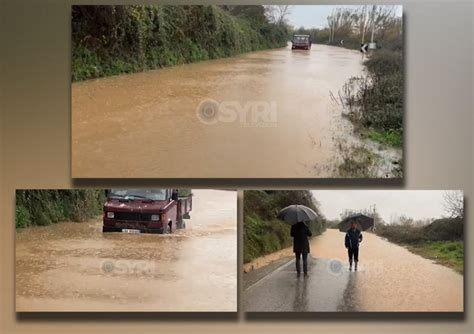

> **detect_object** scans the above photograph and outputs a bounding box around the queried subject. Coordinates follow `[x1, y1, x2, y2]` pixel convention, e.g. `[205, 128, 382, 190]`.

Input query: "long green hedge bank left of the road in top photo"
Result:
[72, 5, 288, 81]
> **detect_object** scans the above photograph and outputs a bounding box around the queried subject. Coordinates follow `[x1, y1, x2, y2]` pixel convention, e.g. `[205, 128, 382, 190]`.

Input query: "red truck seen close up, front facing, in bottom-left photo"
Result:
[102, 189, 192, 233]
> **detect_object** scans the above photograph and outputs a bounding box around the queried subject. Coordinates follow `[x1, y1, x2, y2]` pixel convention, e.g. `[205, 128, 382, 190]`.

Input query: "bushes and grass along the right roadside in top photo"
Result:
[294, 5, 404, 178]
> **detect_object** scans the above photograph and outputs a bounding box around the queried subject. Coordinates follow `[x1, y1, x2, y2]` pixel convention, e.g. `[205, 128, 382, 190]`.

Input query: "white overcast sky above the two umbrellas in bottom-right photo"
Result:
[312, 190, 458, 223]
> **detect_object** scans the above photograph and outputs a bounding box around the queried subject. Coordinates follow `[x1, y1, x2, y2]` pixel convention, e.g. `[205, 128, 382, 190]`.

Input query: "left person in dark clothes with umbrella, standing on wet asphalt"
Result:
[278, 205, 318, 277]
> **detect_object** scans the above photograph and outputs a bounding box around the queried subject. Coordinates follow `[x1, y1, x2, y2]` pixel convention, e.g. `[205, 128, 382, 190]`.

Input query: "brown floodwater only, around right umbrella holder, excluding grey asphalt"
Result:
[311, 229, 464, 312]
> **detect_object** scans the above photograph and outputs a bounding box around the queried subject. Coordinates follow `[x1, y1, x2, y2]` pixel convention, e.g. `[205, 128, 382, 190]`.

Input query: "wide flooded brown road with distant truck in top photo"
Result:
[72, 45, 363, 178]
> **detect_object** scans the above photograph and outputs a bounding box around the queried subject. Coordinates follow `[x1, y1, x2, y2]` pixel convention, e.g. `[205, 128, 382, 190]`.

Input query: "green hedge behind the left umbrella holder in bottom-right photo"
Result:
[244, 190, 326, 263]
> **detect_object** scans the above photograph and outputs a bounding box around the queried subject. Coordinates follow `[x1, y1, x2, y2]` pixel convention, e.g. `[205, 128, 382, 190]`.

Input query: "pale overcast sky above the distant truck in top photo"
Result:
[288, 5, 403, 28]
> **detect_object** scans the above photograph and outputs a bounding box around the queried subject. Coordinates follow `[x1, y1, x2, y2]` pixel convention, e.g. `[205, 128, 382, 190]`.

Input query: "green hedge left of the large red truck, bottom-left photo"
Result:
[15, 189, 105, 228]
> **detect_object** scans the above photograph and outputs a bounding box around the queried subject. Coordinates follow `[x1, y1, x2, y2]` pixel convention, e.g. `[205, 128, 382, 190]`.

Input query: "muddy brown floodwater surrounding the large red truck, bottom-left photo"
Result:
[16, 190, 237, 312]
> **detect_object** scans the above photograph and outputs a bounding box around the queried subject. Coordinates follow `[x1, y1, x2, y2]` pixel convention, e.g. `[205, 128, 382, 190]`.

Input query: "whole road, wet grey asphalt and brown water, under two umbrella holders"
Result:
[243, 229, 464, 312]
